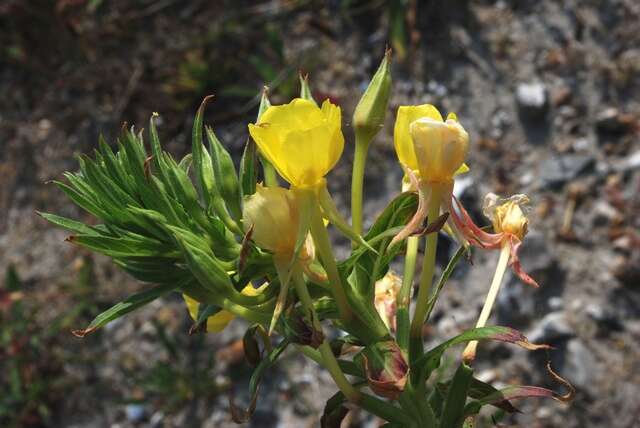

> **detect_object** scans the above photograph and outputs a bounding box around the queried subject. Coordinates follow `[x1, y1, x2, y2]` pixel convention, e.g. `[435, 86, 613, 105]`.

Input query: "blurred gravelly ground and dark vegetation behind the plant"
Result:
[0, 0, 640, 427]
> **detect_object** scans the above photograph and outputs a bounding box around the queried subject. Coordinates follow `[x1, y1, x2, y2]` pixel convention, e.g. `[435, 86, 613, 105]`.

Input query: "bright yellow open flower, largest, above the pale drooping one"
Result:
[249, 98, 344, 188]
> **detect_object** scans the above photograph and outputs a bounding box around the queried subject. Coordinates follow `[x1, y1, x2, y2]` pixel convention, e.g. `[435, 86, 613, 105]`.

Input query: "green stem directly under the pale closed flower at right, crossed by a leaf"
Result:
[410, 185, 442, 361]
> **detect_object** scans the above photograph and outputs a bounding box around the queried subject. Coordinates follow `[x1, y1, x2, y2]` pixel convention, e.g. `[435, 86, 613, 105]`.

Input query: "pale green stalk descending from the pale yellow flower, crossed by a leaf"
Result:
[293, 266, 361, 403]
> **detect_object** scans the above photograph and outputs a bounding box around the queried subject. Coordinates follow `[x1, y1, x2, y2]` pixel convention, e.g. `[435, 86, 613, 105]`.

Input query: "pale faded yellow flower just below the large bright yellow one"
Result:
[242, 185, 300, 261]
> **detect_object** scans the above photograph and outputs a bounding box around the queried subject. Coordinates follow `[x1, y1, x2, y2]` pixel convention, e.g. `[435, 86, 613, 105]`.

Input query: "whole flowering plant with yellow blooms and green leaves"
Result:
[43, 52, 568, 427]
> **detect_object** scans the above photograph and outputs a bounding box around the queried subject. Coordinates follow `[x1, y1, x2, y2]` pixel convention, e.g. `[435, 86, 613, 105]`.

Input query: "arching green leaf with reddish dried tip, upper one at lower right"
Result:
[415, 326, 551, 382]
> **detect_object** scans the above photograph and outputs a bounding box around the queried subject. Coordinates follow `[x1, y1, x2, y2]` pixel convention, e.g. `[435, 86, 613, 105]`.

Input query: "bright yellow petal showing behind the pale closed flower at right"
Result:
[393, 104, 442, 170]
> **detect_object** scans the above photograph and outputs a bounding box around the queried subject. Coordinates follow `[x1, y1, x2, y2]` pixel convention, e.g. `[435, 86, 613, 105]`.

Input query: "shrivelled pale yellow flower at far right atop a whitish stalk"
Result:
[483, 193, 529, 241]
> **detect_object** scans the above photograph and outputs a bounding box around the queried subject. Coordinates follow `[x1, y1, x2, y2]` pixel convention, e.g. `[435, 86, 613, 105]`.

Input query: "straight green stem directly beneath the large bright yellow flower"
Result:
[311, 196, 353, 324]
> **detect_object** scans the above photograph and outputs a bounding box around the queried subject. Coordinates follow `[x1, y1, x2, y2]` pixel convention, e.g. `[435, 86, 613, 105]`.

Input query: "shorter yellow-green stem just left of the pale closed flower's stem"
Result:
[396, 236, 420, 354]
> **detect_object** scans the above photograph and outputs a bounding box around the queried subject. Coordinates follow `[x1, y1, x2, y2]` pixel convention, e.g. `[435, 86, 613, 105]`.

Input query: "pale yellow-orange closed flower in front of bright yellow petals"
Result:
[409, 117, 469, 182]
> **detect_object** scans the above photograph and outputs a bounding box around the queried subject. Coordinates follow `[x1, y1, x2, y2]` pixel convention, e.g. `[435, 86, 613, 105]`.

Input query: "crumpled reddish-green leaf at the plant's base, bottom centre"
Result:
[356, 340, 409, 400]
